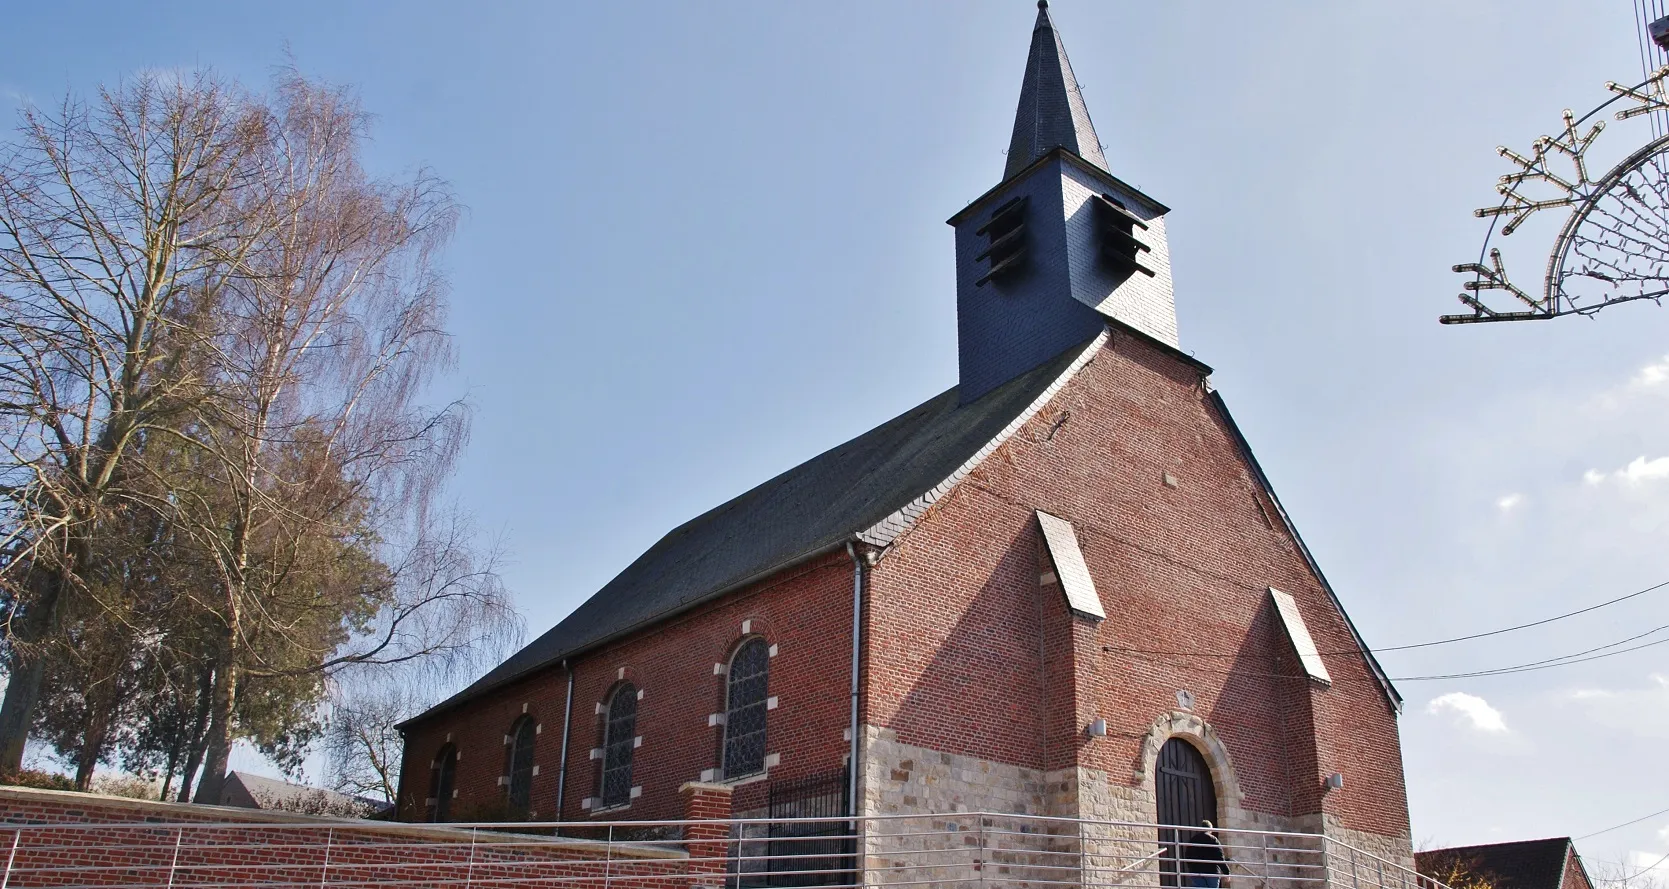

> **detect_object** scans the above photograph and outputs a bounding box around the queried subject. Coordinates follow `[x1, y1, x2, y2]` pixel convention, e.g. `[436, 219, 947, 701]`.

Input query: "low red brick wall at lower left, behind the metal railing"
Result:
[0, 787, 690, 889]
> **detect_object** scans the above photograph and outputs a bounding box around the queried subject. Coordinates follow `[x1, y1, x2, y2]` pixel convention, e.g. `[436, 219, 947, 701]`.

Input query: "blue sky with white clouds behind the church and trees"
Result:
[0, 0, 1669, 861]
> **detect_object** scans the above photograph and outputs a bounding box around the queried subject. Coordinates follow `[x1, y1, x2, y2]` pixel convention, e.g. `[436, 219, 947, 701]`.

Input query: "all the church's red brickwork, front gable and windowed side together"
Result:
[401, 326, 1407, 836]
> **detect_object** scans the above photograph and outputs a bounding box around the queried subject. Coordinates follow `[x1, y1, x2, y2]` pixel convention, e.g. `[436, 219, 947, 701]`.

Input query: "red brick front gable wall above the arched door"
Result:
[866, 328, 1409, 836]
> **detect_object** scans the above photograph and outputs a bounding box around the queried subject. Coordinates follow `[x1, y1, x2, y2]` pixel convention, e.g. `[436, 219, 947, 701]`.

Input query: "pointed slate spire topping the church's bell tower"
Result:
[1003, 0, 1107, 178]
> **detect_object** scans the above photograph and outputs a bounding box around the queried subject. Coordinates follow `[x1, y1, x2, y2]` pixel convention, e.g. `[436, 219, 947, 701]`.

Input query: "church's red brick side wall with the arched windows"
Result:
[399, 552, 853, 821]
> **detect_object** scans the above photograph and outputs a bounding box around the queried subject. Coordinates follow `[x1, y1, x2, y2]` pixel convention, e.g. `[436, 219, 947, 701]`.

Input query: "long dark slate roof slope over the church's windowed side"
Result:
[404, 337, 1100, 726]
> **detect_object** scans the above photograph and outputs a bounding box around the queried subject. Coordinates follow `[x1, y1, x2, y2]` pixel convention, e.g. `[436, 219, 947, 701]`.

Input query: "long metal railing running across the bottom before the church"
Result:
[0, 812, 1449, 889]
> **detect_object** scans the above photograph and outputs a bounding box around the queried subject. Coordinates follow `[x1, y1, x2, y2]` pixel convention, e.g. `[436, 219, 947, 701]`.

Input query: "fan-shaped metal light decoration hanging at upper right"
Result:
[1439, 67, 1669, 324]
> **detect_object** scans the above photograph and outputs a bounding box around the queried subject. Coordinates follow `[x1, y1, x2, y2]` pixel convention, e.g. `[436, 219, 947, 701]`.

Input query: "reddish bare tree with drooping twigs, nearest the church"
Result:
[141, 72, 516, 801]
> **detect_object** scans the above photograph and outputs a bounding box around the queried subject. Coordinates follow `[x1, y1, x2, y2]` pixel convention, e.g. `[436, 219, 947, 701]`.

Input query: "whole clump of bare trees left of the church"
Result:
[0, 72, 519, 790]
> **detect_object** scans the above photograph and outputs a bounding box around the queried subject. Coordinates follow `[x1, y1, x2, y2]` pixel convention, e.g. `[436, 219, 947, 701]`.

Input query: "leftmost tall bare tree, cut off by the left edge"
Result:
[0, 75, 267, 771]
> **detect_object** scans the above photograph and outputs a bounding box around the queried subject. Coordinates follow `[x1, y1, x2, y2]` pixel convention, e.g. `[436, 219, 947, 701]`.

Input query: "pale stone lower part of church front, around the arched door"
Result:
[858, 716, 1415, 889]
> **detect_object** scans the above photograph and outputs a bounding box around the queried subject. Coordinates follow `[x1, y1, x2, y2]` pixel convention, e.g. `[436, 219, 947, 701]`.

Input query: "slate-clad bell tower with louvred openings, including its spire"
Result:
[950, 0, 1177, 404]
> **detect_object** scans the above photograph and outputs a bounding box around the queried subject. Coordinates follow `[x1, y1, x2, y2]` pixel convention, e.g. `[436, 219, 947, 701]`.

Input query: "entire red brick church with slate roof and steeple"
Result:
[399, 3, 1412, 861]
